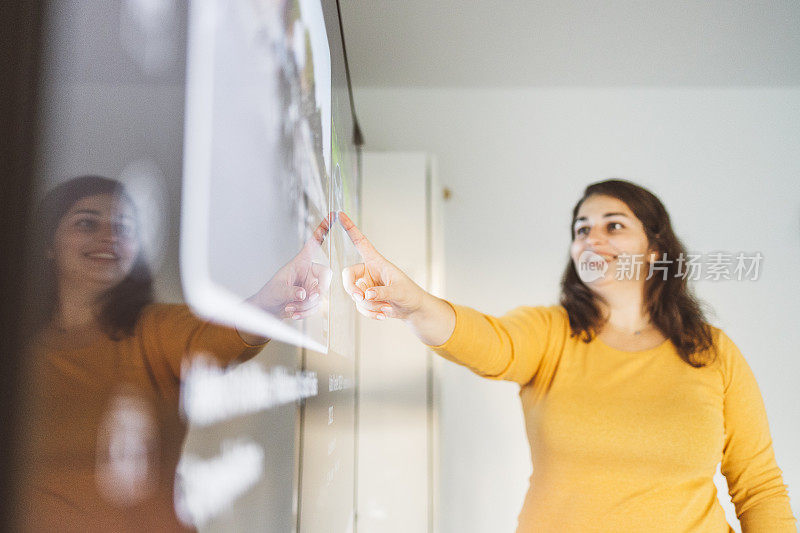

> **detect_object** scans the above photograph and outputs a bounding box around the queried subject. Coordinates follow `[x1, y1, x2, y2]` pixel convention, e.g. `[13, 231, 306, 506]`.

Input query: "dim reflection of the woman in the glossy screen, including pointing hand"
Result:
[21, 176, 329, 531]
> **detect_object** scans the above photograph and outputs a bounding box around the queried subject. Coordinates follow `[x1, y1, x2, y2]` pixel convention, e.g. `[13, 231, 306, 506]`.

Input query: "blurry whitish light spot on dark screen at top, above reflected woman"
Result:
[119, 0, 178, 74]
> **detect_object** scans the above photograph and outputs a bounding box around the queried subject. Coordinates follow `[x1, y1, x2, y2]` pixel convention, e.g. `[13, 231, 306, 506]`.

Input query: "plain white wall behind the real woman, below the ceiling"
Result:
[356, 88, 800, 533]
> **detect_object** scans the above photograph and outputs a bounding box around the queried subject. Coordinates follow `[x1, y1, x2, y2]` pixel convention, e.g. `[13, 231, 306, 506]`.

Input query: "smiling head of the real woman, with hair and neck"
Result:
[561, 180, 713, 366]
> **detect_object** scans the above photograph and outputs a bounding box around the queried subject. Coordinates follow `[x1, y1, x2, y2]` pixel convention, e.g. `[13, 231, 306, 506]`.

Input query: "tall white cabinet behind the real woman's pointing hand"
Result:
[356, 152, 439, 533]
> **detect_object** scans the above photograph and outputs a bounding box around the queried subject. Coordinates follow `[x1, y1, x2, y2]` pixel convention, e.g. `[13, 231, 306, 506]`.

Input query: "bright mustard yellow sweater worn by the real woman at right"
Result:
[432, 304, 796, 533]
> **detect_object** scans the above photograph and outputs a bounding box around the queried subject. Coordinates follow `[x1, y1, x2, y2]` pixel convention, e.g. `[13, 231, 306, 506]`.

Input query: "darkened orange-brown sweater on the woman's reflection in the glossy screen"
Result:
[17, 304, 263, 533]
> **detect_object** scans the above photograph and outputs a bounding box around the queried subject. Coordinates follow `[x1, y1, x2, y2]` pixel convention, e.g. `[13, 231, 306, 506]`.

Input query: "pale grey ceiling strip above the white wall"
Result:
[339, 0, 800, 87]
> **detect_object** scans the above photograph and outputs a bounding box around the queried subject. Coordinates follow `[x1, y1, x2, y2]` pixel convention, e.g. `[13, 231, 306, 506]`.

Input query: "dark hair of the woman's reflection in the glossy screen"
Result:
[29, 176, 153, 339]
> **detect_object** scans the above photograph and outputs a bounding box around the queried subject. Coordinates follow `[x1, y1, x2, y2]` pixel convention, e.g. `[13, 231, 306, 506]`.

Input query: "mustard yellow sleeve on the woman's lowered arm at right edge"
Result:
[719, 331, 796, 533]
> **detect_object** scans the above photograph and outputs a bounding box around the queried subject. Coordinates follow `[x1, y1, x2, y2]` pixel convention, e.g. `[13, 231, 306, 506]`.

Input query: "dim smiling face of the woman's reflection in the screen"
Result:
[50, 194, 140, 289]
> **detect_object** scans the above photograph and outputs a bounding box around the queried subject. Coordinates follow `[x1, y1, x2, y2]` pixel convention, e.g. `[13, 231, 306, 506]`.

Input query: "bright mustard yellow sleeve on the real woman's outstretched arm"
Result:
[430, 302, 566, 385]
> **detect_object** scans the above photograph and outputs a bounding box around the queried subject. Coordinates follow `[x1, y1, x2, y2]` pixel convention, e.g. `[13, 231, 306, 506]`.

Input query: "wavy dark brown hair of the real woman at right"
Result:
[561, 179, 716, 367]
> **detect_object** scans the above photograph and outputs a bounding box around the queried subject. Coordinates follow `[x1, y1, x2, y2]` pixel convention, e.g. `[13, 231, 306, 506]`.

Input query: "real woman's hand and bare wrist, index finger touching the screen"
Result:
[339, 211, 455, 346]
